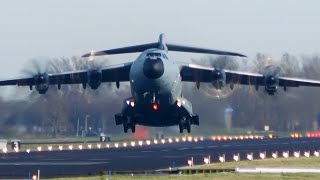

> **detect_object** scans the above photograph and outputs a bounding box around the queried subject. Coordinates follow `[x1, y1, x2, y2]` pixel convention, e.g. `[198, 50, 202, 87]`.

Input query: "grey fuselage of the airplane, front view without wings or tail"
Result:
[122, 49, 192, 126]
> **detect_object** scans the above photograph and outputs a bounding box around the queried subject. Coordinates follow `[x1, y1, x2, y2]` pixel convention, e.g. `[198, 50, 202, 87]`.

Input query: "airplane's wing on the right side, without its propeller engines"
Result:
[180, 64, 320, 87]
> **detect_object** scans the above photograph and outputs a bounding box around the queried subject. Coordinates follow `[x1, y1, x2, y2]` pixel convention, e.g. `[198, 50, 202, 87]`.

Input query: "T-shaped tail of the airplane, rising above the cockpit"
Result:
[82, 34, 246, 57]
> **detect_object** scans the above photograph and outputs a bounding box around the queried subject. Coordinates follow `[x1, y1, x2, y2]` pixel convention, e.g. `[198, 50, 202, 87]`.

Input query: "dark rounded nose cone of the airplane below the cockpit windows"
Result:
[143, 58, 164, 79]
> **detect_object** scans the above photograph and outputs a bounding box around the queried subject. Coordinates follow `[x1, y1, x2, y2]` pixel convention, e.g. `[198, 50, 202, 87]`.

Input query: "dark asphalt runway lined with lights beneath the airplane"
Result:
[0, 138, 320, 179]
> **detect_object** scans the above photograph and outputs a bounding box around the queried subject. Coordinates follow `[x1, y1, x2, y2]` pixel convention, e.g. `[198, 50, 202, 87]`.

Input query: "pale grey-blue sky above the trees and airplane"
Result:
[0, 0, 320, 79]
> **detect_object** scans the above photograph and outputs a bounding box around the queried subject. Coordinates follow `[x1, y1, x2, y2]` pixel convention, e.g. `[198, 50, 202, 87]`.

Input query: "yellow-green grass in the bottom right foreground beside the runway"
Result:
[55, 157, 320, 180]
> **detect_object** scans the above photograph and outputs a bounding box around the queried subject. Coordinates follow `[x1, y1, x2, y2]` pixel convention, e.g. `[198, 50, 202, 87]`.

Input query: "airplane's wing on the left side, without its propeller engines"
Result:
[0, 62, 132, 86]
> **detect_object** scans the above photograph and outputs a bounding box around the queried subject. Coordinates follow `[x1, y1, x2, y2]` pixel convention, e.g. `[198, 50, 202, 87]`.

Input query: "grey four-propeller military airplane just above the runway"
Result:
[0, 34, 320, 133]
